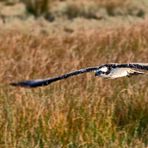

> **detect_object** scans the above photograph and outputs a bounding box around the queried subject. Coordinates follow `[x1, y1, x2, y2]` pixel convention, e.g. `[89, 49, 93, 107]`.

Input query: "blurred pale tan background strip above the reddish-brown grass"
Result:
[0, 0, 148, 33]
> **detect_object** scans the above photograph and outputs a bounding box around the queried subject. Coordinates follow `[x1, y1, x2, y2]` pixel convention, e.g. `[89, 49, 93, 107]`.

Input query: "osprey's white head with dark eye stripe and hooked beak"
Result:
[95, 65, 111, 77]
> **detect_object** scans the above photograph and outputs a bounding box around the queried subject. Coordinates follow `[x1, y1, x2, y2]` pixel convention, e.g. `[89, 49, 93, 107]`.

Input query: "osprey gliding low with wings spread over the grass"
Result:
[10, 63, 148, 87]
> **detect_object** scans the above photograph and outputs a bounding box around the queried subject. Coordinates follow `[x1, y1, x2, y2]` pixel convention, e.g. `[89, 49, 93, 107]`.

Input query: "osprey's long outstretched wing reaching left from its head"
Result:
[10, 67, 99, 87]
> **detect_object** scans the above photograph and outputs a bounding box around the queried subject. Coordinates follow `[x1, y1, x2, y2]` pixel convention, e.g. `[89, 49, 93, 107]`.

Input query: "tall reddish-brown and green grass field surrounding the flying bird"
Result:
[0, 23, 148, 148]
